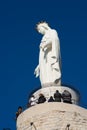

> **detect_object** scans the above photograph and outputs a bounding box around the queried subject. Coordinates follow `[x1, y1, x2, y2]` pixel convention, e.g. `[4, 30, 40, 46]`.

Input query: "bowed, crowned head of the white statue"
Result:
[36, 21, 50, 34]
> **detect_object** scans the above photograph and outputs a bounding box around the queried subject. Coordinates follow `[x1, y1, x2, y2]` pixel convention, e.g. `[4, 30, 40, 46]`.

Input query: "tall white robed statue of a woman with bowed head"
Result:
[34, 22, 61, 86]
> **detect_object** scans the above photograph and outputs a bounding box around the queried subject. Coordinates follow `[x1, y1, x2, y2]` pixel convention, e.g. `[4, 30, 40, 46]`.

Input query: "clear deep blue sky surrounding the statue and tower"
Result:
[0, 0, 87, 130]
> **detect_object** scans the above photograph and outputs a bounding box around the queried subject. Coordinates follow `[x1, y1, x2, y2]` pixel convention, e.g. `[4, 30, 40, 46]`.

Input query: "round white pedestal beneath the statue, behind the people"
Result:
[33, 85, 79, 104]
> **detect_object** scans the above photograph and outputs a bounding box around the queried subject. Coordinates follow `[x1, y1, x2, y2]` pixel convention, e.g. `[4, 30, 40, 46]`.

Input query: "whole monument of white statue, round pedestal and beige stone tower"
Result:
[17, 22, 87, 130]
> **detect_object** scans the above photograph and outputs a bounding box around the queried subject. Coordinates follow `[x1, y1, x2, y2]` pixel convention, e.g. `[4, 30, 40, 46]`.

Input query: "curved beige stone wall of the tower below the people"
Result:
[17, 102, 87, 130]
